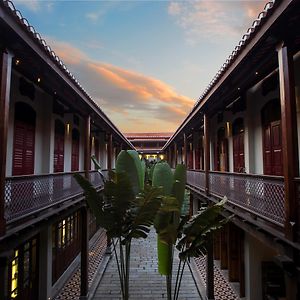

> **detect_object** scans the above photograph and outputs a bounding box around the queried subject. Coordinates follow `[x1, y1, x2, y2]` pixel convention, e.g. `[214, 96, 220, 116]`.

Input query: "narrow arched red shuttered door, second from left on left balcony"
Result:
[54, 120, 65, 172]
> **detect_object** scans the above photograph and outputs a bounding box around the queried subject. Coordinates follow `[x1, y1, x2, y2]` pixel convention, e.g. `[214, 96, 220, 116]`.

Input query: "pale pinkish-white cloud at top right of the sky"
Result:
[168, 0, 265, 44]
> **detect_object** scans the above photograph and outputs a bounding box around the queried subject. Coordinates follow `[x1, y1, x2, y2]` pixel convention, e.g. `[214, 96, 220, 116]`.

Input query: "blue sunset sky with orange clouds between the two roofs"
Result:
[13, 0, 266, 133]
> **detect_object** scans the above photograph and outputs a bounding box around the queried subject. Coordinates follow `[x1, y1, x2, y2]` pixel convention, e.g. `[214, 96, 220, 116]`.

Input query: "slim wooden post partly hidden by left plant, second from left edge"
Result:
[80, 116, 91, 299]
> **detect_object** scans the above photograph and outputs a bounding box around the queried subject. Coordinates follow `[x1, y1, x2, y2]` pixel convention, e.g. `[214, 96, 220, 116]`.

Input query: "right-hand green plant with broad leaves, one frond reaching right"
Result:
[152, 162, 227, 300]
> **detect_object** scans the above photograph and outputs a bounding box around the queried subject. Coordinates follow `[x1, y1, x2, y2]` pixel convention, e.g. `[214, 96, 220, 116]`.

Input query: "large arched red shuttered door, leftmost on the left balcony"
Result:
[12, 102, 36, 176]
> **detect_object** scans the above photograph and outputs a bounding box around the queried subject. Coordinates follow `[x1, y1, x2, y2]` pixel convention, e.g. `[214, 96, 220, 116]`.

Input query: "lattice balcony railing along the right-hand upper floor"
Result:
[187, 171, 285, 226]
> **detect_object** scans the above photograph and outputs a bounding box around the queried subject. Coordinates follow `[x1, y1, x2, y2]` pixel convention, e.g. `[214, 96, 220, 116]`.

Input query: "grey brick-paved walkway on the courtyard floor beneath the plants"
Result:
[93, 231, 201, 300]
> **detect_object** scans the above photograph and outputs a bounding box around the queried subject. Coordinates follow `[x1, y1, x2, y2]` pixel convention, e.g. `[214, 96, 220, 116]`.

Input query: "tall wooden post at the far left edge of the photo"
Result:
[0, 49, 12, 236]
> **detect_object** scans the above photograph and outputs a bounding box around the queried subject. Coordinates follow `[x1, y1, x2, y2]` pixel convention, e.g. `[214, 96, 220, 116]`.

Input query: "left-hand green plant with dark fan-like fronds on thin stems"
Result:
[74, 150, 161, 300]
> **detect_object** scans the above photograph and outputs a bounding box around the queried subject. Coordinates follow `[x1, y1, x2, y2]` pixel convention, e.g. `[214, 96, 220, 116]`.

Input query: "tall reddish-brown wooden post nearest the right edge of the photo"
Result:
[277, 43, 299, 240]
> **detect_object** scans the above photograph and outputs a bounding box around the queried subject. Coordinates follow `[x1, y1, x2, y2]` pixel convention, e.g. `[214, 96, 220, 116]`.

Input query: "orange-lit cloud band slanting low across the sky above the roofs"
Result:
[48, 39, 194, 131]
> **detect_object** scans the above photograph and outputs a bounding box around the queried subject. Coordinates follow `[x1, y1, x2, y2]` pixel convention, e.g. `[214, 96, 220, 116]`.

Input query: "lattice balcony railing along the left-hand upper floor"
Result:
[5, 171, 105, 223]
